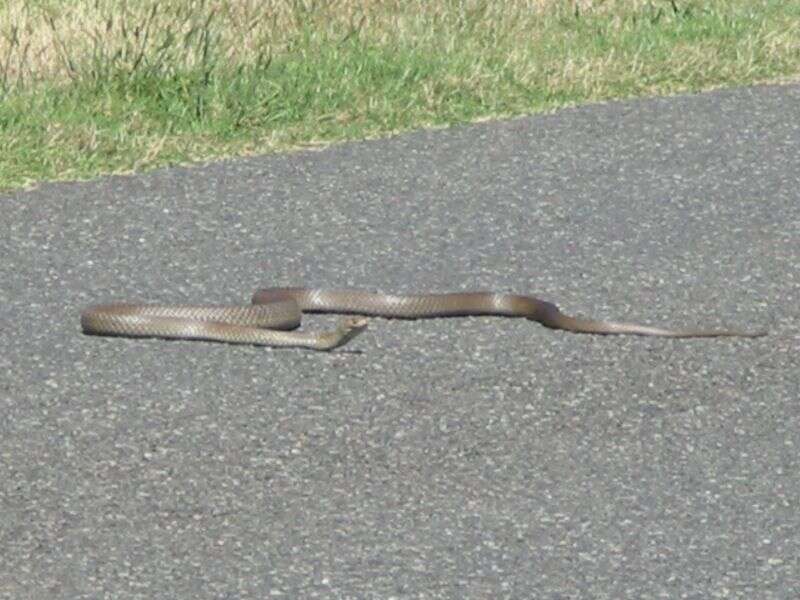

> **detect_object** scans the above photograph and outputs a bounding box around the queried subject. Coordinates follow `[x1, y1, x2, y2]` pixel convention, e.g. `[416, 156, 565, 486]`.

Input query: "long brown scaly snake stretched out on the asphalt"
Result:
[81, 287, 767, 350]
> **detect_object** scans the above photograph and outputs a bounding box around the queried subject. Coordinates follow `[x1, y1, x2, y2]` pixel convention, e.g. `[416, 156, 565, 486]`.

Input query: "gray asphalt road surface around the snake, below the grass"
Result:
[0, 86, 800, 599]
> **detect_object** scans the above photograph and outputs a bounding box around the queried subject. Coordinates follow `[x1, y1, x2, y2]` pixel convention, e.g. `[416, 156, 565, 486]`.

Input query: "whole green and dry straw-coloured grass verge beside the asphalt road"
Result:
[0, 0, 800, 189]
